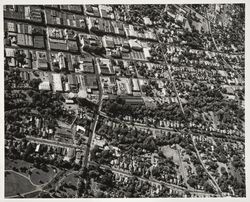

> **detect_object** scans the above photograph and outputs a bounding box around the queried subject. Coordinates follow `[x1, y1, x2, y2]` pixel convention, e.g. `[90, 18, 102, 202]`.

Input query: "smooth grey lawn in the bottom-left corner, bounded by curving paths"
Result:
[4, 171, 35, 197]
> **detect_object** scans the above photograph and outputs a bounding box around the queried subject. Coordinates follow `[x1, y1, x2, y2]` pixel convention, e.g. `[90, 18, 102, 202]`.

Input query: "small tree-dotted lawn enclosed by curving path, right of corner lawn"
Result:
[30, 167, 56, 185]
